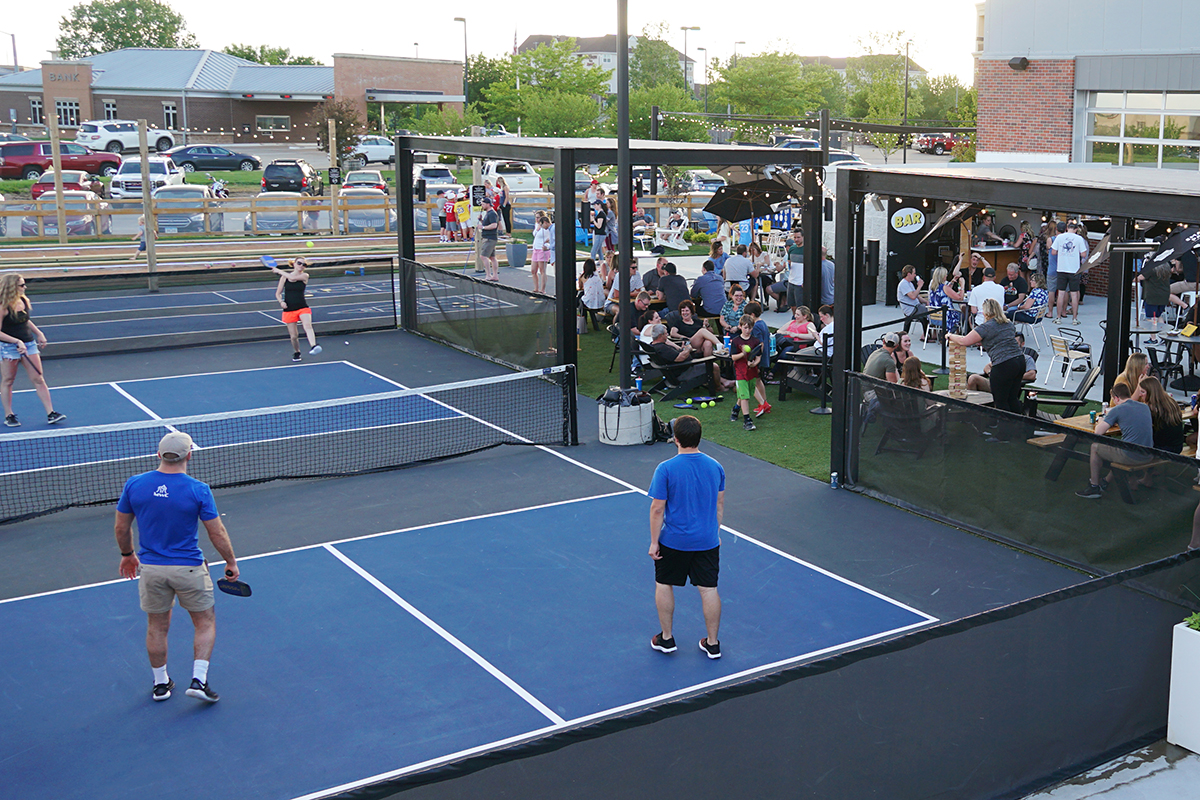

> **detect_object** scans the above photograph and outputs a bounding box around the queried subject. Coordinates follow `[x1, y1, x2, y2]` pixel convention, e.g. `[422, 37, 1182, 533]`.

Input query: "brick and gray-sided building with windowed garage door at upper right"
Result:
[974, 0, 1200, 170]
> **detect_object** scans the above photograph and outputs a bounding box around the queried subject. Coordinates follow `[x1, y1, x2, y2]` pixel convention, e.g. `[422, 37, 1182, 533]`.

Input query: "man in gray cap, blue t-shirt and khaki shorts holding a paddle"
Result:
[116, 431, 238, 703]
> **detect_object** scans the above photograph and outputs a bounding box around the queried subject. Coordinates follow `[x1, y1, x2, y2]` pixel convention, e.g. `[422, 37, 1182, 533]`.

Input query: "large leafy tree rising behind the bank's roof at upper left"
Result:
[55, 0, 199, 59]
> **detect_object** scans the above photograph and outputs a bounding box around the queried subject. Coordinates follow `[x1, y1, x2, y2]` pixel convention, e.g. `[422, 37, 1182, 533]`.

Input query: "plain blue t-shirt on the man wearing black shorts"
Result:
[649, 453, 725, 551]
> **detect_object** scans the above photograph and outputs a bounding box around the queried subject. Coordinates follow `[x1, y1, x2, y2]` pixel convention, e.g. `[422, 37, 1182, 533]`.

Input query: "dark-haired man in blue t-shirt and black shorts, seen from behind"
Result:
[648, 415, 725, 658]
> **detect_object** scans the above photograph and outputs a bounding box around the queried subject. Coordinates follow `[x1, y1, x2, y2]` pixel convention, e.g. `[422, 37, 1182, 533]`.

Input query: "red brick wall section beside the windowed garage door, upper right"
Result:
[976, 59, 1075, 156]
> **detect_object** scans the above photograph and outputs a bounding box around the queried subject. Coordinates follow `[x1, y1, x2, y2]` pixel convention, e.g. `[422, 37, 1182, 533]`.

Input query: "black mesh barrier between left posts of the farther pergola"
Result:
[409, 261, 558, 369]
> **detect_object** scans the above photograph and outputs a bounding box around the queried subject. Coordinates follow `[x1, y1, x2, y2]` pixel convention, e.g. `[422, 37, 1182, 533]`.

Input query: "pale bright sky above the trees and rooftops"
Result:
[0, 0, 976, 85]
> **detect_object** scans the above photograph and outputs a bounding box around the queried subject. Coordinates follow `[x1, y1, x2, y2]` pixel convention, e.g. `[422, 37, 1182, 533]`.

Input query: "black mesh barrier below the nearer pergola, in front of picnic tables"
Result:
[844, 373, 1200, 573]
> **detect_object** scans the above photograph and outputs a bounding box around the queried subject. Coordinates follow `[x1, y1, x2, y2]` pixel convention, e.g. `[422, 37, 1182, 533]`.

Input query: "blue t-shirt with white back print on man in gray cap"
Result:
[116, 470, 220, 566]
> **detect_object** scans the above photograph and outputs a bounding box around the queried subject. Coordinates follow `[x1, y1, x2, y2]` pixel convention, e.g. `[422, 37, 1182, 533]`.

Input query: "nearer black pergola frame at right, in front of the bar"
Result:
[829, 164, 1200, 476]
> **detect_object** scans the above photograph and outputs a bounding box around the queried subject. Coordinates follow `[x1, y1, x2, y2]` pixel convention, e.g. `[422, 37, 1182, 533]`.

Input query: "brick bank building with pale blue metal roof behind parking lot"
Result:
[0, 48, 463, 143]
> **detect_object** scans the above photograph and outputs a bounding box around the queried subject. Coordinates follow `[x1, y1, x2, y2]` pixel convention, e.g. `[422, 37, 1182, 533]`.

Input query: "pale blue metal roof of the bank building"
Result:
[0, 47, 334, 95]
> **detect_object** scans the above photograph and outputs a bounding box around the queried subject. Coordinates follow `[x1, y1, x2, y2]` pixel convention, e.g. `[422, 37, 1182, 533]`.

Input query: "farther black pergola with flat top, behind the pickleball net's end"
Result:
[395, 136, 826, 374]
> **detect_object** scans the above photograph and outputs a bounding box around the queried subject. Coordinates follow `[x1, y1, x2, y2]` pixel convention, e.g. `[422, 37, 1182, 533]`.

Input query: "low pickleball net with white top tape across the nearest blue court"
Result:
[0, 365, 578, 523]
